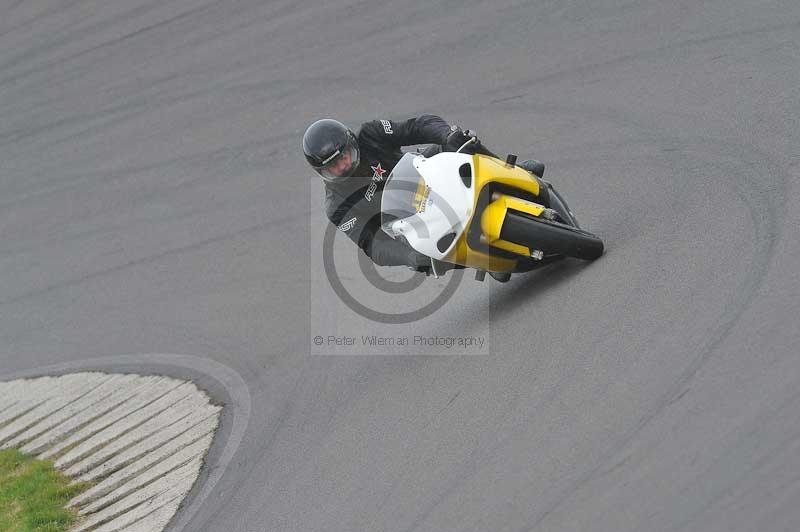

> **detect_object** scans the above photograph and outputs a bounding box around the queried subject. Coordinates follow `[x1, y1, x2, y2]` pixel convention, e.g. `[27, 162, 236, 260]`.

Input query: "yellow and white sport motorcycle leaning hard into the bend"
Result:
[381, 137, 603, 281]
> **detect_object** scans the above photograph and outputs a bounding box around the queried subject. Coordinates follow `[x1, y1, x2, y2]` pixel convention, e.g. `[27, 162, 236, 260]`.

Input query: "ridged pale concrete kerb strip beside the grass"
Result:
[0, 372, 221, 532]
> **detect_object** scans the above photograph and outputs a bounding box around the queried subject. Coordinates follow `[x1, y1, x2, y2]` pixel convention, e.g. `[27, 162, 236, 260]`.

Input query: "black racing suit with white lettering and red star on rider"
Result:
[325, 115, 451, 268]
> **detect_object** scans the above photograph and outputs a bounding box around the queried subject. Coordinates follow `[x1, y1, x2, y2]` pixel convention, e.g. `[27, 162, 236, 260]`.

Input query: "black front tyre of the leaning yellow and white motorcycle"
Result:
[500, 210, 603, 260]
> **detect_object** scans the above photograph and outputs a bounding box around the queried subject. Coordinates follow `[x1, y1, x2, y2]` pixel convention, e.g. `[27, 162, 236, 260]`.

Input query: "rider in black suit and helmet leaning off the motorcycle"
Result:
[303, 115, 544, 282]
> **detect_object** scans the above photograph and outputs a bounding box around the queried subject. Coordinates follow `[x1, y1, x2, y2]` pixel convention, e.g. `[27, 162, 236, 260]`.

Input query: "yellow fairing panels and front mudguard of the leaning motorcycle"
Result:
[445, 155, 543, 272]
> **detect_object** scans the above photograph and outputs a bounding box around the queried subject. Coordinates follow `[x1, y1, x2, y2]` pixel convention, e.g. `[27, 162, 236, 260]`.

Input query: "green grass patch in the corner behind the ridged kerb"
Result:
[0, 449, 88, 532]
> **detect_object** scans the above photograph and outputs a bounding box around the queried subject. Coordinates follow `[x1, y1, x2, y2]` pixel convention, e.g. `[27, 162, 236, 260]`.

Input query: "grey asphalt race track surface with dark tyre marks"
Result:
[0, 0, 800, 532]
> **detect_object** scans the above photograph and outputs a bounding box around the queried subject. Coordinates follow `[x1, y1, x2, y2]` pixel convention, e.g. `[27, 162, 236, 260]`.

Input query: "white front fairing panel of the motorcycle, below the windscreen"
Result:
[391, 153, 475, 260]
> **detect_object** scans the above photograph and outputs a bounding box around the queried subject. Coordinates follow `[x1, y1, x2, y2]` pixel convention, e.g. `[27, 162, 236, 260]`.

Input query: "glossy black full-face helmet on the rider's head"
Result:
[303, 118, 359, 182]
